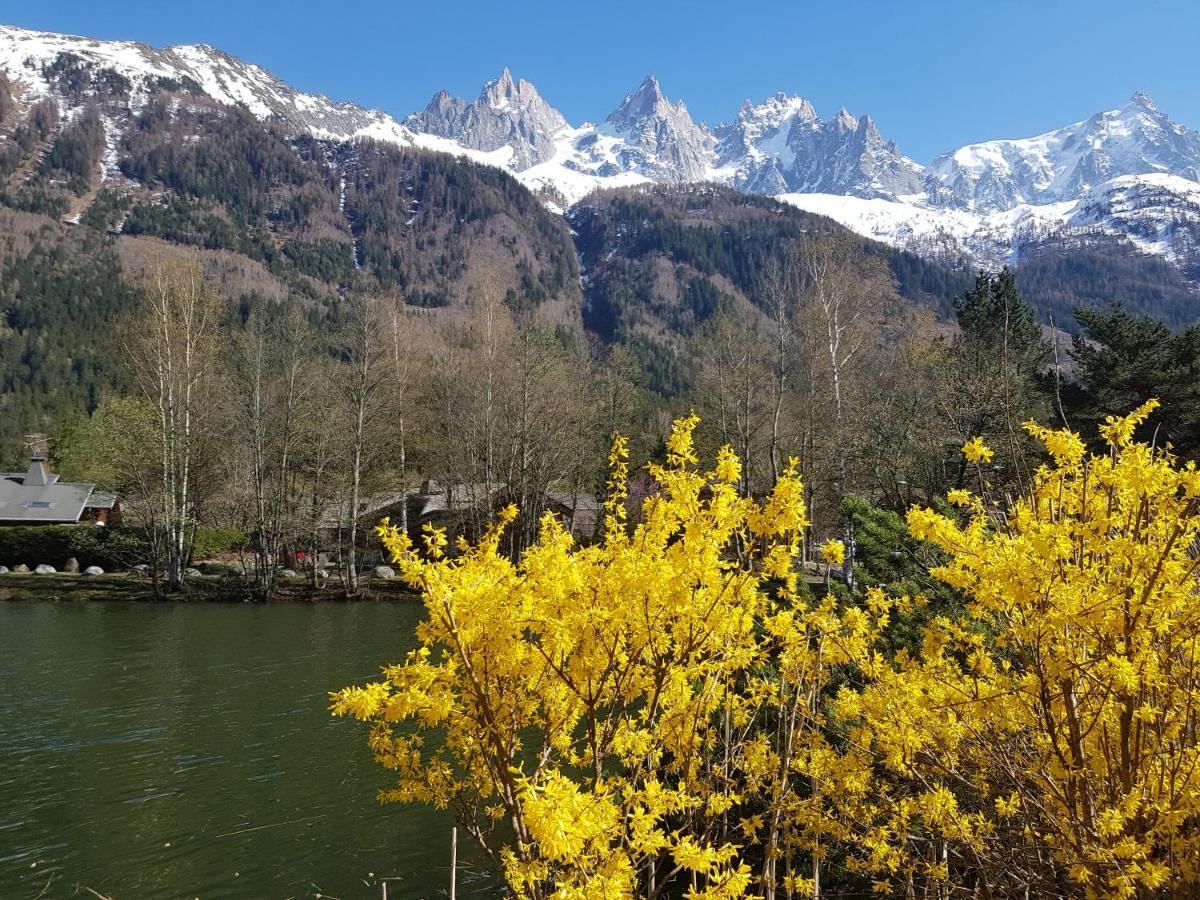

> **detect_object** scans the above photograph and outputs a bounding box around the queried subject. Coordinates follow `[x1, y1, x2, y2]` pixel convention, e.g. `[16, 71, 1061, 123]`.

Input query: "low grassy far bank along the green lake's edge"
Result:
[0, 572, 421, 605]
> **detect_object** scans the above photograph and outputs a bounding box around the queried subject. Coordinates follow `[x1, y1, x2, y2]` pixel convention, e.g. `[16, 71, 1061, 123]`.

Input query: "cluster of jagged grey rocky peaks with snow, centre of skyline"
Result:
[404, 71, 907, 205]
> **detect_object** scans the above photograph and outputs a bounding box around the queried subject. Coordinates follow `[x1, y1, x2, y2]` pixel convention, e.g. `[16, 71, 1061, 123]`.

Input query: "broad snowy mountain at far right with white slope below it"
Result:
[780, 94, 1200, 281]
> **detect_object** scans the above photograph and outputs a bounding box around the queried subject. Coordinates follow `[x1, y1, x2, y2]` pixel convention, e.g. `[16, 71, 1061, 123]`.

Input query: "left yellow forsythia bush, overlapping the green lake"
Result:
[331, 416, 830, 900]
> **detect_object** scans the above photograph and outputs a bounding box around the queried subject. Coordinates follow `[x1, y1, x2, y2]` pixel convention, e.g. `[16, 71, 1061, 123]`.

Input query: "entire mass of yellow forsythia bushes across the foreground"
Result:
[332, 404, 1200, 899]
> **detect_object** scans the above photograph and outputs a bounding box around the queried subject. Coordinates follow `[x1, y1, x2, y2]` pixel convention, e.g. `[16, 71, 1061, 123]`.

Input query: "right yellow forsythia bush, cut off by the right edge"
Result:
[864, 401, 1200, 898]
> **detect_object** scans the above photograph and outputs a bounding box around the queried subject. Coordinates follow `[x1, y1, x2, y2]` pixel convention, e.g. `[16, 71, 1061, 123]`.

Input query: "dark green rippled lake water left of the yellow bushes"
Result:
[0, 602, 496, 900]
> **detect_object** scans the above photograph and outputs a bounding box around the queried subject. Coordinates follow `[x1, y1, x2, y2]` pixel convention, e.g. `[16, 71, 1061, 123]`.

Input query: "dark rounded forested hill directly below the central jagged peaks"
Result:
[568, 185, 971, 394]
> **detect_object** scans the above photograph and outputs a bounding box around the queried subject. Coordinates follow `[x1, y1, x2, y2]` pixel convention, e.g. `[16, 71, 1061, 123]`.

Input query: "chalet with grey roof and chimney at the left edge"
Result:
[0, 451, 120, 526]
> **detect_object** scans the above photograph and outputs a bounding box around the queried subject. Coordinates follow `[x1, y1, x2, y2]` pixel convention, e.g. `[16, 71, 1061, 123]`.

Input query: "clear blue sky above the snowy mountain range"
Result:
[0, 0, 1200, 162]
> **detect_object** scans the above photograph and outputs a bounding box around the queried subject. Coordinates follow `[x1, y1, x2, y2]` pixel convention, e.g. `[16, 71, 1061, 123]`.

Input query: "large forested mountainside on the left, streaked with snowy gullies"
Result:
[0, 68, 581, 462]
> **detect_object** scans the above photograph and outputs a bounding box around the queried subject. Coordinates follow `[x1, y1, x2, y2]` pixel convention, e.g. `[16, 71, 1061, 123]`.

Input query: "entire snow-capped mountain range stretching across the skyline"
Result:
[7, 25, 1200, 280]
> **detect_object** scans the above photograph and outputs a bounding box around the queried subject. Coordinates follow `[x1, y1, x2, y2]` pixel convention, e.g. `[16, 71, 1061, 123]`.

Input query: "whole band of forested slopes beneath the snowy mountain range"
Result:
[0, 60, 1200, 460]
